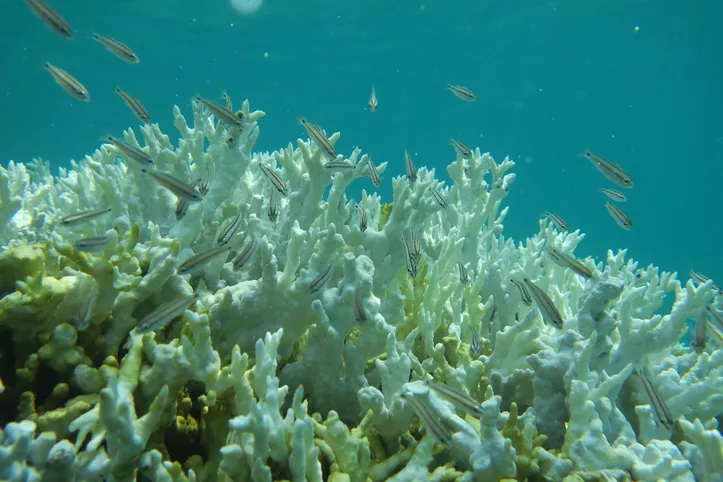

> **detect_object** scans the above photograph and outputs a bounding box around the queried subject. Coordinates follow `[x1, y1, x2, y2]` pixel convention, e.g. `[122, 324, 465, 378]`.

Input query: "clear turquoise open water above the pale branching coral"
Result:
[0, 0, 723, 284]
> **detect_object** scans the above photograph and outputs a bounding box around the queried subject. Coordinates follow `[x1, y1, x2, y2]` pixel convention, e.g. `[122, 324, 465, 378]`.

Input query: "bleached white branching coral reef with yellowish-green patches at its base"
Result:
[0, 102, 723, 482]
